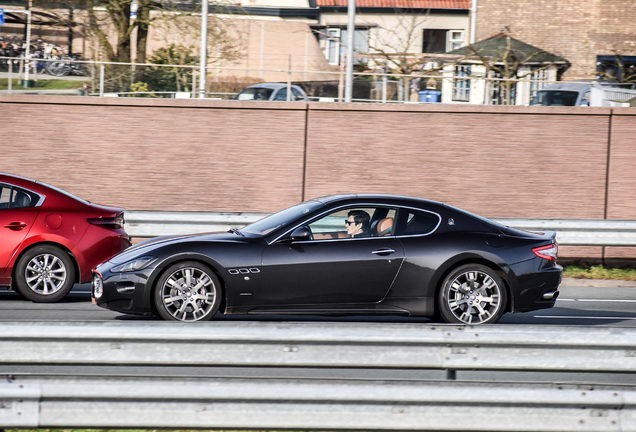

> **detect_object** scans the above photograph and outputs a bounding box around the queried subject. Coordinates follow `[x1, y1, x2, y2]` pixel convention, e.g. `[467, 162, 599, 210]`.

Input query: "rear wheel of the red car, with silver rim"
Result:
[14, 245, 75, 303]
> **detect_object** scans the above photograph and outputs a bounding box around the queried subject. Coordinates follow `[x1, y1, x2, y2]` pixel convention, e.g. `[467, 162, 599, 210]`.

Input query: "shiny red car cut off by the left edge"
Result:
[0, 173, 130, 303]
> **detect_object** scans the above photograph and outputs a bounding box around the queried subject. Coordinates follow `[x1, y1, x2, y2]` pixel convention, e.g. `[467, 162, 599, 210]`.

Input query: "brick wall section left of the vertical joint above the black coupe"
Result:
[0, 96, 305, 212]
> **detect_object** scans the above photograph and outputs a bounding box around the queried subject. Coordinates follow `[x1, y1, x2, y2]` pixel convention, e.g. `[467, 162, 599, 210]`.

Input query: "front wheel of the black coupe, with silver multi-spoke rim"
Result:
[154, 261, 221, 322]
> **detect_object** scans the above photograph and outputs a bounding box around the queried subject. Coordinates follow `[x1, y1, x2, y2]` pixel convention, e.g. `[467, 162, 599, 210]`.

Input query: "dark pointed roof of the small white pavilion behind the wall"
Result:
[446, 33, 568, 63]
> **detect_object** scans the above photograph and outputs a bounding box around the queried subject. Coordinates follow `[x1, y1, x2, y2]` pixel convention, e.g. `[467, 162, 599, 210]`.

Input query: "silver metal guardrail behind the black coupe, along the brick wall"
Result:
[126, 210, 636, 246]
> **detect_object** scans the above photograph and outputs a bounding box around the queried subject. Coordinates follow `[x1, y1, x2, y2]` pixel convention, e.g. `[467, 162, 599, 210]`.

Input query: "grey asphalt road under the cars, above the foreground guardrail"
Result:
[0, 281, 636, 327]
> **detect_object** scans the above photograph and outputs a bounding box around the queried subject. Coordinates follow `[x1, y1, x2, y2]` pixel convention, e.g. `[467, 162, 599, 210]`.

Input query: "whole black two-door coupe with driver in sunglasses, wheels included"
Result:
[92, 195, 562, 324]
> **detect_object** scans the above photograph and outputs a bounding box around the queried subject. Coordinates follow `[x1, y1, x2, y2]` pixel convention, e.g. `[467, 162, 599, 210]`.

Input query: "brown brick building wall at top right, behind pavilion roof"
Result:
[476, 0, 636, 80]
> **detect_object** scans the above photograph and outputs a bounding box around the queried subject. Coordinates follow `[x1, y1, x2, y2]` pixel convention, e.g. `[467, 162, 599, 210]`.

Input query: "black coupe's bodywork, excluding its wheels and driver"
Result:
[94, 195, 562, 317]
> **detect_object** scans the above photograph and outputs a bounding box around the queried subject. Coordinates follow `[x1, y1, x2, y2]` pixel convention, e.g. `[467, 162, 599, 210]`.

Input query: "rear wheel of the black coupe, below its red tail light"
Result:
[438, 264, 508, 325]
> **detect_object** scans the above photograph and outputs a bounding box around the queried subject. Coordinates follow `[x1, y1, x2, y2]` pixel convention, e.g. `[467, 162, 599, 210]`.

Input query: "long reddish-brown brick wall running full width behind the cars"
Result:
[0, 95, 636, 258]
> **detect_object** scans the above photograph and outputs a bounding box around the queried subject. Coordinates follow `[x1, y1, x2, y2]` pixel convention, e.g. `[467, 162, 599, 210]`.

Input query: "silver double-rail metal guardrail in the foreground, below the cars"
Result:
[0, 322, 636, 432]
